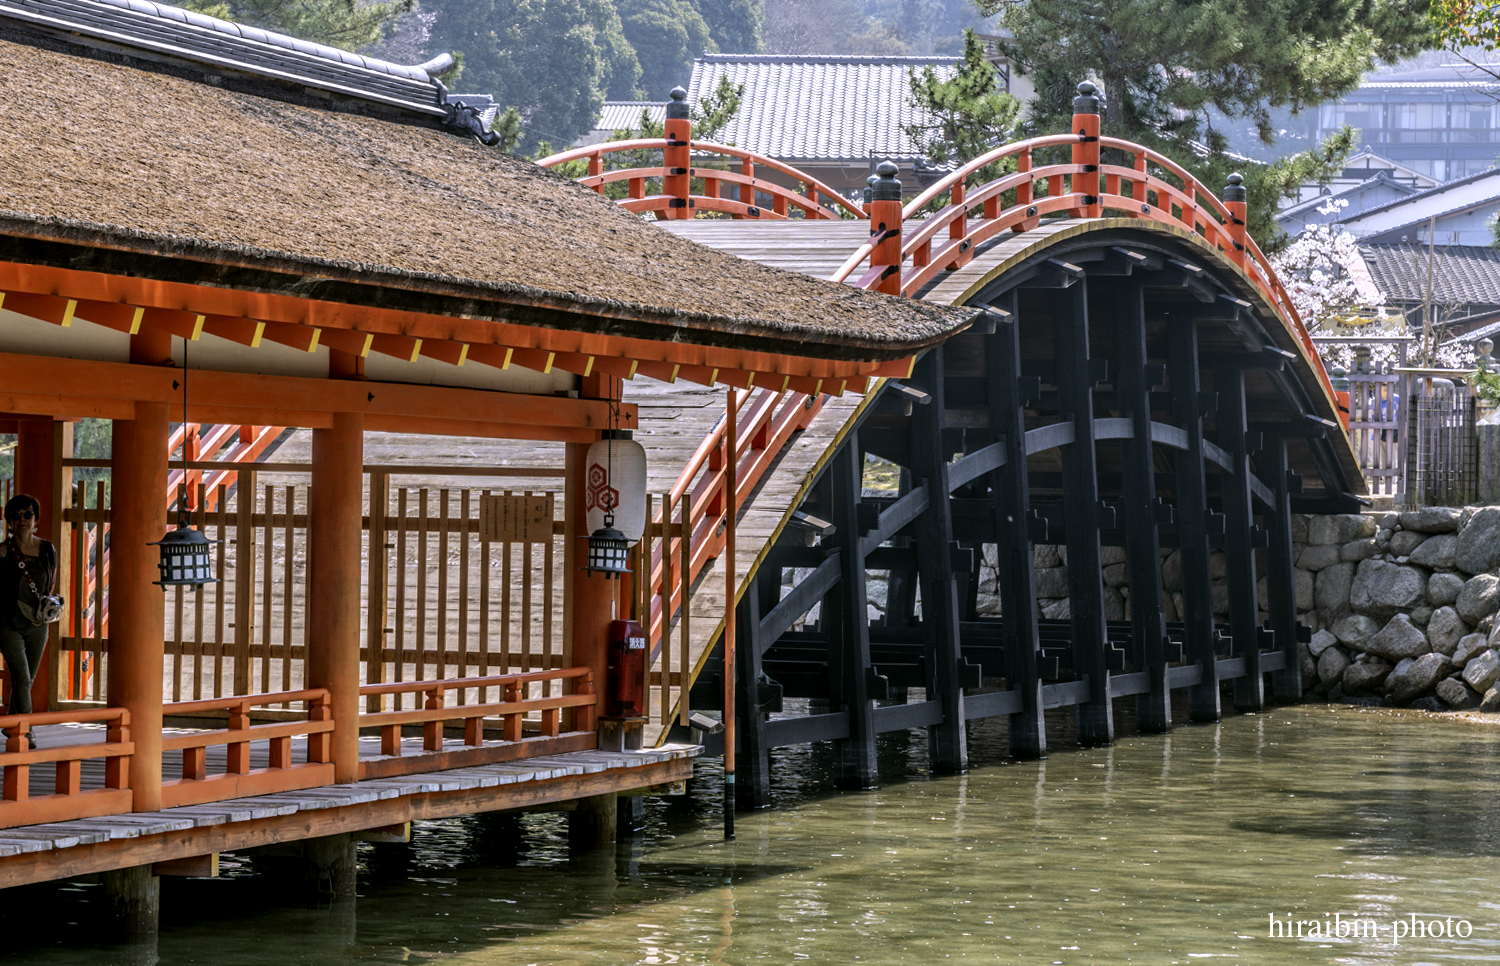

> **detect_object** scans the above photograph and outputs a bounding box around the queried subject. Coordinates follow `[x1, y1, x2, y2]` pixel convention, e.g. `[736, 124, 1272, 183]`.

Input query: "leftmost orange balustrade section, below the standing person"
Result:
[0, 708, 135, 828]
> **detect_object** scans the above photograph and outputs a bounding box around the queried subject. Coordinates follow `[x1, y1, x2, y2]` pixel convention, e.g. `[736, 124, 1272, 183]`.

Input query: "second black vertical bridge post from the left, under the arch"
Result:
[821, 441, 876, 788]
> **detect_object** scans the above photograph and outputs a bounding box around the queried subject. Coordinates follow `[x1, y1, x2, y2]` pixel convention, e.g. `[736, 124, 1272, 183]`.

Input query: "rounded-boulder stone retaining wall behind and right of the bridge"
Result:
[948, 507, 1500, 711]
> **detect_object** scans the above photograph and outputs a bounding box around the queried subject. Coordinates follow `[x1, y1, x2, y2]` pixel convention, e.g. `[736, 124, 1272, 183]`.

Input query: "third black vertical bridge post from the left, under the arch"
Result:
[906, 345, 969, 774]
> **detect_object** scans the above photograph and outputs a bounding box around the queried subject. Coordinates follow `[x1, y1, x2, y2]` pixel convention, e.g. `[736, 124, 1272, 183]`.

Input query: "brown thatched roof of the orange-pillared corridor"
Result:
[0, 30, 969, 360]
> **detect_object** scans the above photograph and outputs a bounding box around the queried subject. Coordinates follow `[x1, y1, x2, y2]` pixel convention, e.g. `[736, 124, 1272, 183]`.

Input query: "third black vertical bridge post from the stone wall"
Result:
[1167, 318, 1220, 722]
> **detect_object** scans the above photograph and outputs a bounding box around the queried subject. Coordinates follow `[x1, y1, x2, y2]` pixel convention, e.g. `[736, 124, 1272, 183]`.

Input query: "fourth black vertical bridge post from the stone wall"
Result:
[1115, 285, 1172, 732]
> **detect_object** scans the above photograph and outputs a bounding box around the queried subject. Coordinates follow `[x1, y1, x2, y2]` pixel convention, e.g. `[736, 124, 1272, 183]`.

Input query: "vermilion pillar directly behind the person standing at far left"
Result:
[15, 417, 74, 711]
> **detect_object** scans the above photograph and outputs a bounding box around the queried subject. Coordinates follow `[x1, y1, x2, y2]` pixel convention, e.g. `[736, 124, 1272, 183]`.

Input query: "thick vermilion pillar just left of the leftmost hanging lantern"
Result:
[108, 402, 167, 812]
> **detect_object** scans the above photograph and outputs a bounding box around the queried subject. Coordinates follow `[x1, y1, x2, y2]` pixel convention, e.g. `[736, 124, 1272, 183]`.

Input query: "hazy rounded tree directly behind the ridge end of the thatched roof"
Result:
[428, 0, 638, 147]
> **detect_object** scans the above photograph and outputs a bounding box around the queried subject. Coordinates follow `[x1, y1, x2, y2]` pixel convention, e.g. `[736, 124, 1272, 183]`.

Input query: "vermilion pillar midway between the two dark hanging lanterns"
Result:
[306, 413, 361, 783]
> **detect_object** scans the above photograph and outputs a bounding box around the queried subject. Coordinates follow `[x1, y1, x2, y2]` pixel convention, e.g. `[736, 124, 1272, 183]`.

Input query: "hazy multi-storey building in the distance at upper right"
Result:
[1317, 65, 1500, 182]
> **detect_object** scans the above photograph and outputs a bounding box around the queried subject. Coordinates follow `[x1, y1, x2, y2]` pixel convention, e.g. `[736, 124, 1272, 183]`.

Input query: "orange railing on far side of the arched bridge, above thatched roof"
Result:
[537, 138, 870, 221]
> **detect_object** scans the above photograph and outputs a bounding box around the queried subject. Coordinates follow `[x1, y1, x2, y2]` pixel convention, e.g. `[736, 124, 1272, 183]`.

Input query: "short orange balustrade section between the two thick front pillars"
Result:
[162, 687, 333, 809]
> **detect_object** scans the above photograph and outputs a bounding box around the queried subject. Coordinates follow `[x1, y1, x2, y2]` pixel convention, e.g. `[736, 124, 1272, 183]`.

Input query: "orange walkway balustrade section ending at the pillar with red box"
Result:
[360, 668, 599, 779]
